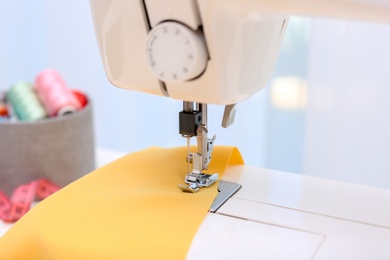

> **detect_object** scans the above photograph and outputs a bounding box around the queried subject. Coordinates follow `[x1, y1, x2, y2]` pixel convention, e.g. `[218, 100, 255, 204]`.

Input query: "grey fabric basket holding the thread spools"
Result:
[0, 102, 95, 195]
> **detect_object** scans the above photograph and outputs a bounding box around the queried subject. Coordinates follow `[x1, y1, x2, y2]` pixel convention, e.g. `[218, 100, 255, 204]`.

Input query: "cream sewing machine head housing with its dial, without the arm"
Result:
[91, 0, 287, 105]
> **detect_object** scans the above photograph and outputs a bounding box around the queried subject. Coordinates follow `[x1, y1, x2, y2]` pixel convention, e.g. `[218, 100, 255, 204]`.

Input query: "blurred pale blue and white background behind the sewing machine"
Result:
[0, 0, 390, 188]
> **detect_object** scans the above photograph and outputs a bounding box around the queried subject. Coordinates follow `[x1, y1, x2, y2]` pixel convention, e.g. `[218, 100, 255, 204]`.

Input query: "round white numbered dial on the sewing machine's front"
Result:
[146, 22, 208, 82]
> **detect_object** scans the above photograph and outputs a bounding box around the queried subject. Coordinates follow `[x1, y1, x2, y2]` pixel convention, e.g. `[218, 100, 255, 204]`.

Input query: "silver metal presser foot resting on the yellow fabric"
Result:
[179, 173, 218, 193]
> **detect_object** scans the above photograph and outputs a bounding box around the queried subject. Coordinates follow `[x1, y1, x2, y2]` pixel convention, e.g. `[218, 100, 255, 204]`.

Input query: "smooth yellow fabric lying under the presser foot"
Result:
[0, 147, 243, 260]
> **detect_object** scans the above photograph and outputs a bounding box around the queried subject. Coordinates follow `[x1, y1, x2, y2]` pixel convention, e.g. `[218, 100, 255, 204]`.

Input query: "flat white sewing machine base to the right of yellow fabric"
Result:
[188, 166, 390, 259]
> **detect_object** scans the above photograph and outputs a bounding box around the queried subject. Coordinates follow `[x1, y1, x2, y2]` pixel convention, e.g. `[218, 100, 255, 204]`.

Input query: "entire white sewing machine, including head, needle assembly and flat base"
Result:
[91, 0, 390, 259]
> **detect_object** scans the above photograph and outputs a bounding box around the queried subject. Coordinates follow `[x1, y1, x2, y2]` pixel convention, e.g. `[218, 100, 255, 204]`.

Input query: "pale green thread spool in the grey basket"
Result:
[7, 81, 47, 121]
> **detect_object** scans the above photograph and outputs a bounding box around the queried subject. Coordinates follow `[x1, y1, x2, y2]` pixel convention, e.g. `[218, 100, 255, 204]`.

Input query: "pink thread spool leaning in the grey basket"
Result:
[35, 69, 81, 116]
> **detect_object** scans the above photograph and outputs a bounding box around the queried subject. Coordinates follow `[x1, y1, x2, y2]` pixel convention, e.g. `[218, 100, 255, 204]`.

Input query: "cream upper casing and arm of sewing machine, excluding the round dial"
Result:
[91, 0, 390, 105]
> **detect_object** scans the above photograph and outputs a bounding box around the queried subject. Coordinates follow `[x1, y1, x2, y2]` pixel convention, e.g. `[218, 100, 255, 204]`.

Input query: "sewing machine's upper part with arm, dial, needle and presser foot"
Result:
[91, 0, 390, 191]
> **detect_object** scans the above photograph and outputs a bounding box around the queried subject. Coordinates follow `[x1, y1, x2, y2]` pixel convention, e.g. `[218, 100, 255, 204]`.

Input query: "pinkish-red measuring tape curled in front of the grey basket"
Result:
[0, 179, 61, 222]
